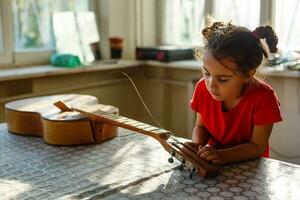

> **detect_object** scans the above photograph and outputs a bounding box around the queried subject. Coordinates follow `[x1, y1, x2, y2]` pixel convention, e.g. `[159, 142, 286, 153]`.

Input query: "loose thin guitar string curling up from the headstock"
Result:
[103, 71, 181, 139]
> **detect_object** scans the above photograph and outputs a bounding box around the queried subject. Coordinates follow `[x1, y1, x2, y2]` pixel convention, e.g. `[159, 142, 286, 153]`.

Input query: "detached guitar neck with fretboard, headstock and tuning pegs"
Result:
[55, 101, 220, 178]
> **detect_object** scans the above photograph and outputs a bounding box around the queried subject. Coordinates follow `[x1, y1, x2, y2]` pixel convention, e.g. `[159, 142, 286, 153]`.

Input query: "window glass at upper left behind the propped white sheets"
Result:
[12, 0, 89, 51]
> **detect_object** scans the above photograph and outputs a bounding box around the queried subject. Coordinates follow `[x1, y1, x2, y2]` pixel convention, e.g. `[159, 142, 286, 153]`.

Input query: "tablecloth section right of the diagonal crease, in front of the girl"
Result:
[90, 159, 300, 200]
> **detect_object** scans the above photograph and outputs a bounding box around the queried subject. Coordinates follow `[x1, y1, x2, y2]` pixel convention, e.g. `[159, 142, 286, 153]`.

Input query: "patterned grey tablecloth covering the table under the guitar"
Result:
[0, 124, 300, 200]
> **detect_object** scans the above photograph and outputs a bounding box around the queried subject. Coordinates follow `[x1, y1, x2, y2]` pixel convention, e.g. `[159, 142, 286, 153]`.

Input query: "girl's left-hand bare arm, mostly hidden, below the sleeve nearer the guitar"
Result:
[192, 113, 210, 146]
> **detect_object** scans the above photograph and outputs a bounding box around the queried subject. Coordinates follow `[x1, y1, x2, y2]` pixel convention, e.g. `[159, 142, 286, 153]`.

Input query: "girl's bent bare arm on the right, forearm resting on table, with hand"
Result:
[198, 124, 273, 164]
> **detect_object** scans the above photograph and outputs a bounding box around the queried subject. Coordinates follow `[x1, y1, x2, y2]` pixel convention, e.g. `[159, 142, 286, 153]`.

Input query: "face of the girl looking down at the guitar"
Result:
[203, 50, 254, 102]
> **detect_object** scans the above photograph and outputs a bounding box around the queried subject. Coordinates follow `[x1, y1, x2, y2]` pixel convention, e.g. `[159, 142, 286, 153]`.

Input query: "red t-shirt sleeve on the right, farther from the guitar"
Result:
[253, 90, 282, 125]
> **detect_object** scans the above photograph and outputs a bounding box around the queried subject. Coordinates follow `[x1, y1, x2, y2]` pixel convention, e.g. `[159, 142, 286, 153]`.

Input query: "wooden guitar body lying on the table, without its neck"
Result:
[5, 94, 119, 145]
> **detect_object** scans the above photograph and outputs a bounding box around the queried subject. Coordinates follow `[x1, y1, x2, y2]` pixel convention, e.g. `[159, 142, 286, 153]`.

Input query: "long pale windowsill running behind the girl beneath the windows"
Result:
[0, 60, 300, 81]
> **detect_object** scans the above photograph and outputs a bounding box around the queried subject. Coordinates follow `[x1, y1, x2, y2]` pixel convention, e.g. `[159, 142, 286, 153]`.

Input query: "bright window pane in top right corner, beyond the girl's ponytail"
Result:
[274, 0, 300, 50]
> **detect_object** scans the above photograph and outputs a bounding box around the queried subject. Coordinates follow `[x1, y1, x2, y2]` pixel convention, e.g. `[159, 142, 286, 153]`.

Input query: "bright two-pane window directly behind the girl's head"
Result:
[162, 0, 261, 45]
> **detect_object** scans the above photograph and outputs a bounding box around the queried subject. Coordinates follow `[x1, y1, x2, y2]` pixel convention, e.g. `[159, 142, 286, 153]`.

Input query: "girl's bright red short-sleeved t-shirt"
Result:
[190, 79, 282, 157]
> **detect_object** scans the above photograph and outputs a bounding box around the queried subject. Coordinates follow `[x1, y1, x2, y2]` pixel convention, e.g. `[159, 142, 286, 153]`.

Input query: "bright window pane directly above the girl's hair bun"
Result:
[213, 0, 260, 30]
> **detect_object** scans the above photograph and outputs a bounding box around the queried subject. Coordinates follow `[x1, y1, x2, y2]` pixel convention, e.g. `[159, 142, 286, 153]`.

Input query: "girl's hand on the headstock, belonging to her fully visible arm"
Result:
[197, 145, 222, 164]
